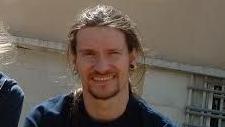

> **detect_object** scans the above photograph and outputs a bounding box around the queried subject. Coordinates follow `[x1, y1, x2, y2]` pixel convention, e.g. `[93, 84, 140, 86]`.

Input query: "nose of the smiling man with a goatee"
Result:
[94, 57, 110, 74]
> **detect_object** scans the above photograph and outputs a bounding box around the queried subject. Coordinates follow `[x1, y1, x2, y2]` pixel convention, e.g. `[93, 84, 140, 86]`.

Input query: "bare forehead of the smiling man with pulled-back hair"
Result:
[77, 27, 127, 50]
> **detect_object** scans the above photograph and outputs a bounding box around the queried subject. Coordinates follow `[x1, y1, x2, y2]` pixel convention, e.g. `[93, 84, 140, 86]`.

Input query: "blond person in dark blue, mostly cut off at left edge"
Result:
[0, 22, 24, 127]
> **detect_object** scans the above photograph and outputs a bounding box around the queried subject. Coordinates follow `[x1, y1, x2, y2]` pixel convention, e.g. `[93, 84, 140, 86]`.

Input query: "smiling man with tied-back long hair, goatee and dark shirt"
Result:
[24, 5, 176, 127]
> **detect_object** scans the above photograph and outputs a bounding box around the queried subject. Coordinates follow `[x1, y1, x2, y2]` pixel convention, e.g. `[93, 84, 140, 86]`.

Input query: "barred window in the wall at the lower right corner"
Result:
[184, 75, 225, 127]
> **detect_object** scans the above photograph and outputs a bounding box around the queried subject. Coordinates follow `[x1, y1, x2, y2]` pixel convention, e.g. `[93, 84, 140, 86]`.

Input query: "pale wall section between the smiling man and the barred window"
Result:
[143, 68, 190, 125]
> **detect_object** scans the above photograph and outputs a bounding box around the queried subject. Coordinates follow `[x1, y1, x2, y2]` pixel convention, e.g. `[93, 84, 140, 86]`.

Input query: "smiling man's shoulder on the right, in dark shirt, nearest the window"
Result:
[135, 97, 176, 127]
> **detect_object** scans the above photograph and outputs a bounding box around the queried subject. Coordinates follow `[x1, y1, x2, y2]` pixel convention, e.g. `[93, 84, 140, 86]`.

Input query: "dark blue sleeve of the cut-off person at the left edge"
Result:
[0, 72, 24, 127]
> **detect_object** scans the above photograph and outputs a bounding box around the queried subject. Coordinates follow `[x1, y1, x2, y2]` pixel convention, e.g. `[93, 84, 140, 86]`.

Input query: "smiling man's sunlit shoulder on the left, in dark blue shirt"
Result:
[24, 94, 72, 127]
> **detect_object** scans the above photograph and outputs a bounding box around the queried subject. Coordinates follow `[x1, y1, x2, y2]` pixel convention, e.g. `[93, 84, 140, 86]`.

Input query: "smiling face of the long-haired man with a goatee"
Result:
[74, 27, 134, 100]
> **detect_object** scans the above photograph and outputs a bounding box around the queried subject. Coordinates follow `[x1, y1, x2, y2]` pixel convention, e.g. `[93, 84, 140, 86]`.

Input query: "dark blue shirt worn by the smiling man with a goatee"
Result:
[24, 94, 175, 127]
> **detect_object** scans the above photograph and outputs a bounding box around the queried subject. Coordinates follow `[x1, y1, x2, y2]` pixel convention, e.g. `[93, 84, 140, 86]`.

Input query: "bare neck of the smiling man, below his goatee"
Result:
[83, 85, 129, 122]
